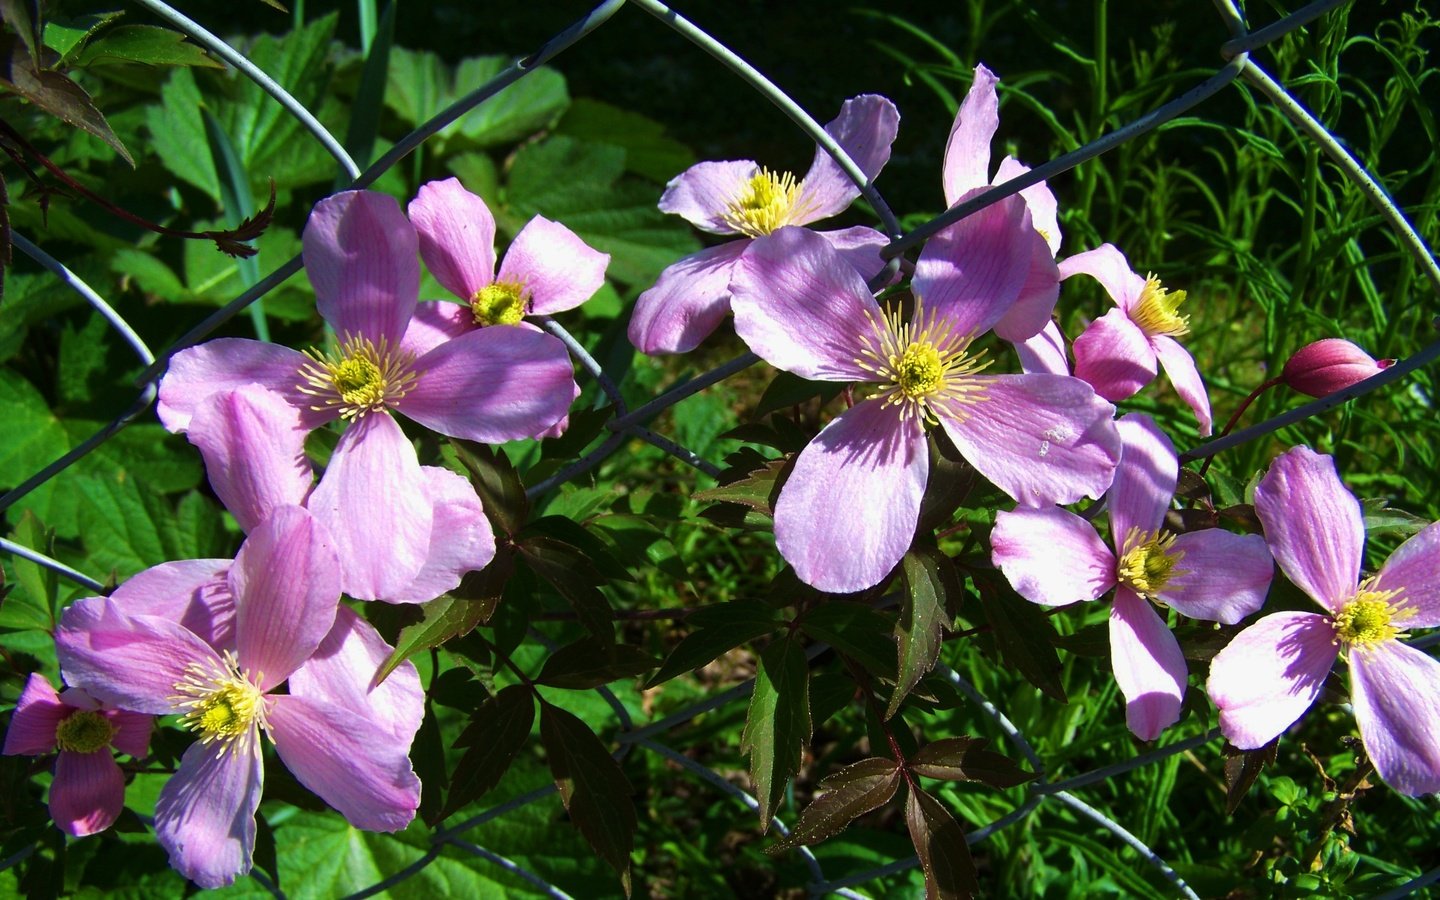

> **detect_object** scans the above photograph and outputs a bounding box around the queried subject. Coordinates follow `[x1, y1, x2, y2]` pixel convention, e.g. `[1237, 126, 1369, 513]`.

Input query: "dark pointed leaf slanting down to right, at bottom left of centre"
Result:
[540, 703, 635, 896]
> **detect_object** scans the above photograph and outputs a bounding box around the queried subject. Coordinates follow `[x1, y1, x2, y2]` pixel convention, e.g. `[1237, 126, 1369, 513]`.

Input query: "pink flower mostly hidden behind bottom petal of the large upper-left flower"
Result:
[187, 384, 495, 603]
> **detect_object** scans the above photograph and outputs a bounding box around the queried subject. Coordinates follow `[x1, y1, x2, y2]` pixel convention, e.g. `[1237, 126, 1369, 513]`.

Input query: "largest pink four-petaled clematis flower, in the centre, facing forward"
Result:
[733, 224, 1120, 592]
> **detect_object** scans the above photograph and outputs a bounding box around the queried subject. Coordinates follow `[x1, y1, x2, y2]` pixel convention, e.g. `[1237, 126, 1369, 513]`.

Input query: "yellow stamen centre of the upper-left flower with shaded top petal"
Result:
[298, 337, 419, 419]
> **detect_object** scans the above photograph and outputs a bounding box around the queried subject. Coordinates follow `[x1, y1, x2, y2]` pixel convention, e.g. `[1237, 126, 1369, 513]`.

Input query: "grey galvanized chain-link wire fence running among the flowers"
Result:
[0, 0, 1440, 897]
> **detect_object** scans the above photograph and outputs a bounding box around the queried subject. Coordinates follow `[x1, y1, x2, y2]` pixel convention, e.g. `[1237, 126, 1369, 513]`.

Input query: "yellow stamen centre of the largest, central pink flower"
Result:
[855, 301, 989, 423]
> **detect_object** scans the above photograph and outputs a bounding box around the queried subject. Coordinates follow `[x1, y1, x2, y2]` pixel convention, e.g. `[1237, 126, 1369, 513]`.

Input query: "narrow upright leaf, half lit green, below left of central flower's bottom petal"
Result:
[740, 634, 811, 831]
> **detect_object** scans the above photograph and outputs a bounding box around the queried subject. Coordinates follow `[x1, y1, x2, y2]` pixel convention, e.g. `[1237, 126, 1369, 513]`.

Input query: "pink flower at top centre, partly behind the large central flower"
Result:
[629, 94, 900, 354]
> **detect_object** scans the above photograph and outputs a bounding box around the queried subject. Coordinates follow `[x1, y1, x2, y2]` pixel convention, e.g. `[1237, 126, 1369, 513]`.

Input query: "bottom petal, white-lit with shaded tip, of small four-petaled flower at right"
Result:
[1110, 586, 1187, 740]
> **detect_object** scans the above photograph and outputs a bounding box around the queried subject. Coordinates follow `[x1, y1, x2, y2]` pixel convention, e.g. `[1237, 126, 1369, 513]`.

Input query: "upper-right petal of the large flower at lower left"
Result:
[289, 606, 425, 747]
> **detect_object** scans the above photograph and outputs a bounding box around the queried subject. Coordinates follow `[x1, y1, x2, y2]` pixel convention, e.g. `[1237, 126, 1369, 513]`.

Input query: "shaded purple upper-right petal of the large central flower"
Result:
[912, 190, 1036, 338]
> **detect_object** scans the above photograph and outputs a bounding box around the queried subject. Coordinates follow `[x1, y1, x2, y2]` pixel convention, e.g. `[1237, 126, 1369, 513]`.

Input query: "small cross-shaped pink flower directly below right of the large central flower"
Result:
[991, 413, 1274, 740]
